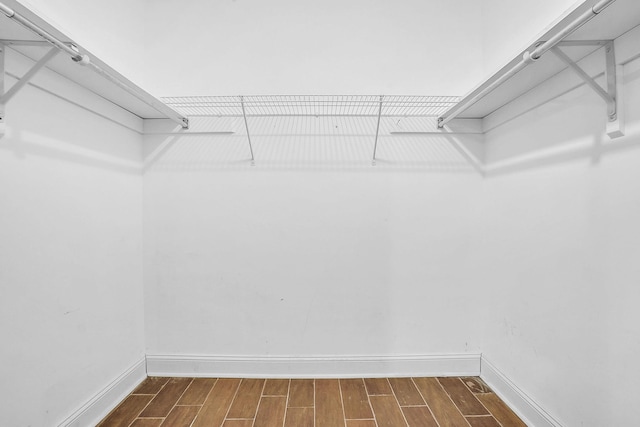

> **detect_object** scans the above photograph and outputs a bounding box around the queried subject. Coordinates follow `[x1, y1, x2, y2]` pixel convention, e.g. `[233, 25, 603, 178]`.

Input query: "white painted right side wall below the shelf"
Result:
[479, 55, 640, 427]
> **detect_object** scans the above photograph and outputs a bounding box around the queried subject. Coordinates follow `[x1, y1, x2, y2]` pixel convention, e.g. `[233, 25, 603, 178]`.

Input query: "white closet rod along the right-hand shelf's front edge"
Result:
[438, 0, 615, 128]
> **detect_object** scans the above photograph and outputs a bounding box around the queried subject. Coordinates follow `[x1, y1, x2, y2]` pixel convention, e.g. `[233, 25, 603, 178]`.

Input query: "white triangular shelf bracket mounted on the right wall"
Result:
[551, 40, 624, 138]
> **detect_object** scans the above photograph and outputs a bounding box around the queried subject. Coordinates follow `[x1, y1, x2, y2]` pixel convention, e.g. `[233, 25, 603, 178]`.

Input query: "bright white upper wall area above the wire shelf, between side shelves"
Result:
[13, 0, 575, 96]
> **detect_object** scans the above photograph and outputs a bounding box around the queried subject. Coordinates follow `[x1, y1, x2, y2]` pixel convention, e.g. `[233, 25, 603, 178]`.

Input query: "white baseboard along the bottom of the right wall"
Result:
[480, 355, 562, 427]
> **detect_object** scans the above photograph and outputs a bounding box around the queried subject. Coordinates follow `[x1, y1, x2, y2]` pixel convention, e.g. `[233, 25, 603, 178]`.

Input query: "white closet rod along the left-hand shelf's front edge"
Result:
[0, 2, 189, 128]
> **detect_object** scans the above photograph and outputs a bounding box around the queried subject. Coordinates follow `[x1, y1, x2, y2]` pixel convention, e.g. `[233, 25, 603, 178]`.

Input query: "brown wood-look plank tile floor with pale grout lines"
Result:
[99, 377, 526, 427]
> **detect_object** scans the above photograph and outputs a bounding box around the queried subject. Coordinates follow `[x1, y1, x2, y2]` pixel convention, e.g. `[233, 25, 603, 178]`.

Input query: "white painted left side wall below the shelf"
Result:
[0, 50, 144, 426]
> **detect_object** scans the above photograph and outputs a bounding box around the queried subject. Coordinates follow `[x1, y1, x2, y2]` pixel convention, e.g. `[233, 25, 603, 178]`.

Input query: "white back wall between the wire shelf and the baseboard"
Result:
[144, 118, 482, 357]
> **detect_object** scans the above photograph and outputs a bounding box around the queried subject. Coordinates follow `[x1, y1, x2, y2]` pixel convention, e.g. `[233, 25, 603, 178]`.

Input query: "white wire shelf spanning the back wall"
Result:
[162, 95, 460, 117]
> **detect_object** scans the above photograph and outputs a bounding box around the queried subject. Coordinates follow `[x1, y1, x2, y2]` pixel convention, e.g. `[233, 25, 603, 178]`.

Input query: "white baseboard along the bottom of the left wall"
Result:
[58, 359, 147, 427]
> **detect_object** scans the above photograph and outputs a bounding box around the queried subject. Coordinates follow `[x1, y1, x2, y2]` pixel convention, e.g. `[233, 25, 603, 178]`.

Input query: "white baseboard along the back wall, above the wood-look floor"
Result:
[147, 354, 480, 378]
